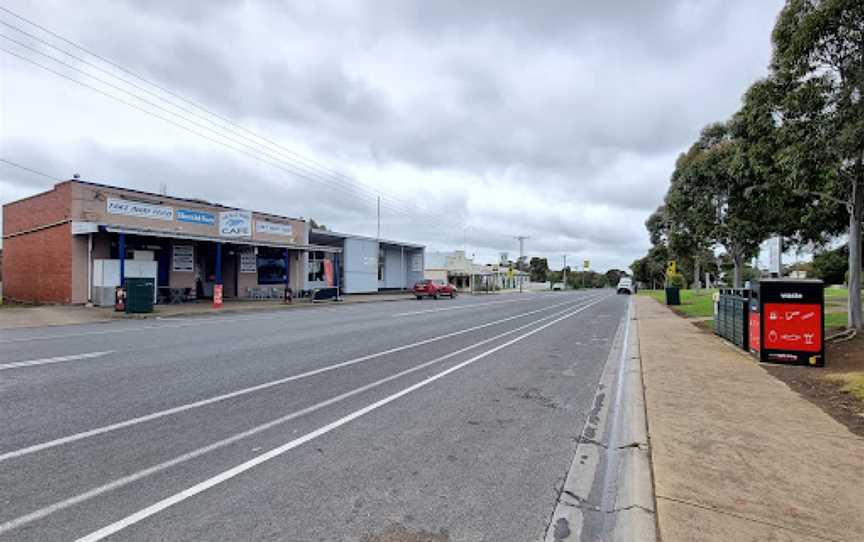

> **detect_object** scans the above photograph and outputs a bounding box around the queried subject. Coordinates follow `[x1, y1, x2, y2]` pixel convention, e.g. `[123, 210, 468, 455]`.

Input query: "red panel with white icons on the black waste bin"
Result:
[763, 303, 822, 352]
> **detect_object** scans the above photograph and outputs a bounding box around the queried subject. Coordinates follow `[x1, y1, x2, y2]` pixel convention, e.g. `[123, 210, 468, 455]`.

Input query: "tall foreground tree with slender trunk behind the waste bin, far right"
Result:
[771, 0, 864, 329]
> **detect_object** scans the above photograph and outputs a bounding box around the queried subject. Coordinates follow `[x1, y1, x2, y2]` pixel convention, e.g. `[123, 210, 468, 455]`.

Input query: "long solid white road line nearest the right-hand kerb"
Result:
[77, 297, 606, 542]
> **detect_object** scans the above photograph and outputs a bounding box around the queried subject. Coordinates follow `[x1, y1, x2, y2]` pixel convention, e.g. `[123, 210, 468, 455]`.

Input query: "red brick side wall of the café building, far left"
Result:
[3, 183, 72, 303]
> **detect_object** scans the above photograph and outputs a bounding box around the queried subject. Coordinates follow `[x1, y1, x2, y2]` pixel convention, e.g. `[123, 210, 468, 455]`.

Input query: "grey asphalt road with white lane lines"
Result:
[0, 291, 627, 542]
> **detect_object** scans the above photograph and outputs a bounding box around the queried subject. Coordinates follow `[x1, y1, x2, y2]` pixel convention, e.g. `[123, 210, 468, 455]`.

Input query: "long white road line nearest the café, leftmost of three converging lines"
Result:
[0, 299, 596, 462]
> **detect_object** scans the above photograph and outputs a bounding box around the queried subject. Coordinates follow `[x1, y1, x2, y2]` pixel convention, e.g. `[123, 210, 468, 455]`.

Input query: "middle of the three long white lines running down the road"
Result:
[0, 299, 616, 534]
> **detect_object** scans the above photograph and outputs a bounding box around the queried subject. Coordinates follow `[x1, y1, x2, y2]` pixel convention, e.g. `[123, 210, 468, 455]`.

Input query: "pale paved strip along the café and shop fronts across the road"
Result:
[0, 292, 414, 330]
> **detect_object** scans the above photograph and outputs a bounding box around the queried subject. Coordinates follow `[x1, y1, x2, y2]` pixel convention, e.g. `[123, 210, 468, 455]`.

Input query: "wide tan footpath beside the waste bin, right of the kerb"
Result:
[635, 296, 864, 542]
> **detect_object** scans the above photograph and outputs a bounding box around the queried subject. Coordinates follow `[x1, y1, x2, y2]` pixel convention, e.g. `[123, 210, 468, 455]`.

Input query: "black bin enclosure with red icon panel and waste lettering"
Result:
[749, 279, 825, 367]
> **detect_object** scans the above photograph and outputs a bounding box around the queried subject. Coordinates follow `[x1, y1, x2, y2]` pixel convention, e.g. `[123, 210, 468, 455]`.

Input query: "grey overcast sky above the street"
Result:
[0, 0, 782, 270]
